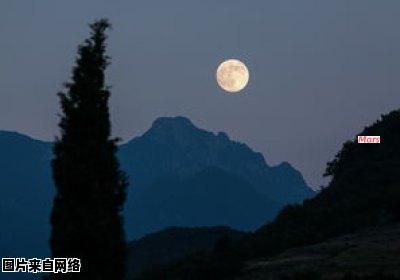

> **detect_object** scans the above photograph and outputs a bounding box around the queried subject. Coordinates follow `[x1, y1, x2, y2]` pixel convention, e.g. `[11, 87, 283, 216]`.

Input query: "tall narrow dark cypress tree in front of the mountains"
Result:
[49, 19, 127, 280]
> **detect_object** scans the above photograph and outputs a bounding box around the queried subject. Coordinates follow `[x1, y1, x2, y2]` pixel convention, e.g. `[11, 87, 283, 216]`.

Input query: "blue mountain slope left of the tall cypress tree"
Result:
[0, 131, 54, 280]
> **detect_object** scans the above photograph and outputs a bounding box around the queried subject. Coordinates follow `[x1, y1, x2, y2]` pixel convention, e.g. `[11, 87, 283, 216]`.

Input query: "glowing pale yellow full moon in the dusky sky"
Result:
[216, 59, 249, 93]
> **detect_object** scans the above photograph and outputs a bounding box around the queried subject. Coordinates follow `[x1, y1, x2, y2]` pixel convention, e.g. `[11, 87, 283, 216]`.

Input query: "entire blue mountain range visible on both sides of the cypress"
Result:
[0, 117, 314, 280]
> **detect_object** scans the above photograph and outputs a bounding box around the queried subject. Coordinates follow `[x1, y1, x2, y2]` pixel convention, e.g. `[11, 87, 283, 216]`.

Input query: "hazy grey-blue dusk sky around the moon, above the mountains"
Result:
[0, 0, 400, 186]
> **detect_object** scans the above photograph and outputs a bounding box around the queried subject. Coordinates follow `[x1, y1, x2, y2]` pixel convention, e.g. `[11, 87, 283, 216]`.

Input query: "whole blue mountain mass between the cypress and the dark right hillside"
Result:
[119, 117, 314, 238]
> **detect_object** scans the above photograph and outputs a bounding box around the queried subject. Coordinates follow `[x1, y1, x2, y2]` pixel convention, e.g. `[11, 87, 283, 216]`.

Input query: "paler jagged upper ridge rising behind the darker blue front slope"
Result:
[120, 117, 313, 204]
